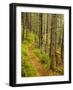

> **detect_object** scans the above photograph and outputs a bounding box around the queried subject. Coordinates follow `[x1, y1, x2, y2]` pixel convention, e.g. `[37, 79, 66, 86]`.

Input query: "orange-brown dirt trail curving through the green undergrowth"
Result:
[28, 45, 49, 76]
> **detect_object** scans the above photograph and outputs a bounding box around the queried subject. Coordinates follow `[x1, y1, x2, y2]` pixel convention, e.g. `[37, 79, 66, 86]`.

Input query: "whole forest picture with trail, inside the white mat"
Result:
[21, 12, 64, 77]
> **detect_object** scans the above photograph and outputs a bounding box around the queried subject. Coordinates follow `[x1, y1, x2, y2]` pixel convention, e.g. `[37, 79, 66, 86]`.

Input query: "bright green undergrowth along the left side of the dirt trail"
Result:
[21, 42, 37, 77]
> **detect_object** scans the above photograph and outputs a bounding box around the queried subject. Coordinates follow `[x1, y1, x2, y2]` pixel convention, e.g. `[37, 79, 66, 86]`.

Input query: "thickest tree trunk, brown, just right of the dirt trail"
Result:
[51, 14, 57, 70]
